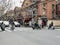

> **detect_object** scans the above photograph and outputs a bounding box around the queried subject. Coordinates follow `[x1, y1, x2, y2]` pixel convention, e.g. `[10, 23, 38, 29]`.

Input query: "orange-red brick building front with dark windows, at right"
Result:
[38, 0, 57, 19]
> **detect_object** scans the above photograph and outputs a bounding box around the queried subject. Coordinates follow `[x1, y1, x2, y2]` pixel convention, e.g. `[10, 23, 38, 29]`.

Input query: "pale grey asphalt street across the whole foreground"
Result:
[0, 27, 60, 45]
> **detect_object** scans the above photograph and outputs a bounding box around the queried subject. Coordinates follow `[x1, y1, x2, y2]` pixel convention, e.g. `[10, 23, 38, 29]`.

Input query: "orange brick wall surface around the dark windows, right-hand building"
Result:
[38, 1, 56, 19]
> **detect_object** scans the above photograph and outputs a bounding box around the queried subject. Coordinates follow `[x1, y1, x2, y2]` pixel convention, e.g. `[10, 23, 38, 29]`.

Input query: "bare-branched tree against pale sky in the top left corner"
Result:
[0, 0, 12, 20]
